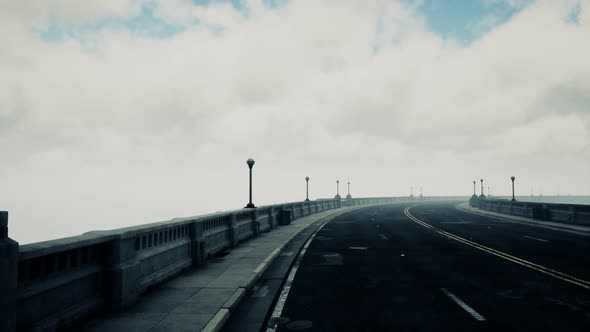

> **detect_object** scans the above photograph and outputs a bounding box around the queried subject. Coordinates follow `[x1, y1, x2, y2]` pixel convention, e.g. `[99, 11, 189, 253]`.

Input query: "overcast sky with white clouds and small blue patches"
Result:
[0, 0, 590, 243]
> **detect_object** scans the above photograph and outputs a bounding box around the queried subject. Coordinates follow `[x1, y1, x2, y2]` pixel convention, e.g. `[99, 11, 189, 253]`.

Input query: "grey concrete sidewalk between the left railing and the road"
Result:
[81, 206, 362, 332]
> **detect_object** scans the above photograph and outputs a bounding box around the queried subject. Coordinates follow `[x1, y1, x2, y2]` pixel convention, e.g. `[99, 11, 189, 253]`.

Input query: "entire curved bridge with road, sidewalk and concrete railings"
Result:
[0, 195, 590, 331]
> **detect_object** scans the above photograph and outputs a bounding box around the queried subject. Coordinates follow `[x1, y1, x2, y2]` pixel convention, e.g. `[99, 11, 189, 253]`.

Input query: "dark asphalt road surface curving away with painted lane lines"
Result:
[227, 203, 590, 332]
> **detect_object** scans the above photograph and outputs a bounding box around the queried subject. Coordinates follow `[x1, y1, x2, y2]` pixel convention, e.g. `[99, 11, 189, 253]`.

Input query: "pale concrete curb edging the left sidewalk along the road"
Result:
[201, 205, 366, 332]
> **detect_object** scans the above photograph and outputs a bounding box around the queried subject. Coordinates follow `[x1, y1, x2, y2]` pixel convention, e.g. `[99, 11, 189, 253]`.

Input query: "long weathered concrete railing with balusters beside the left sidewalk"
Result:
[0, 197, 464, 331]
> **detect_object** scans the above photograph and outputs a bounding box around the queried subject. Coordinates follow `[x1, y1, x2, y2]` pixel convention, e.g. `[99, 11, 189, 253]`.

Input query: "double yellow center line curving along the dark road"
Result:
[404, 205, 590, 289]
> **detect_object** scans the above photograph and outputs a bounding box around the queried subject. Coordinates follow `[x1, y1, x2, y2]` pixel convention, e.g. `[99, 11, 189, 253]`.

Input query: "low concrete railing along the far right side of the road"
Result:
[469, 197, 590, 226]
